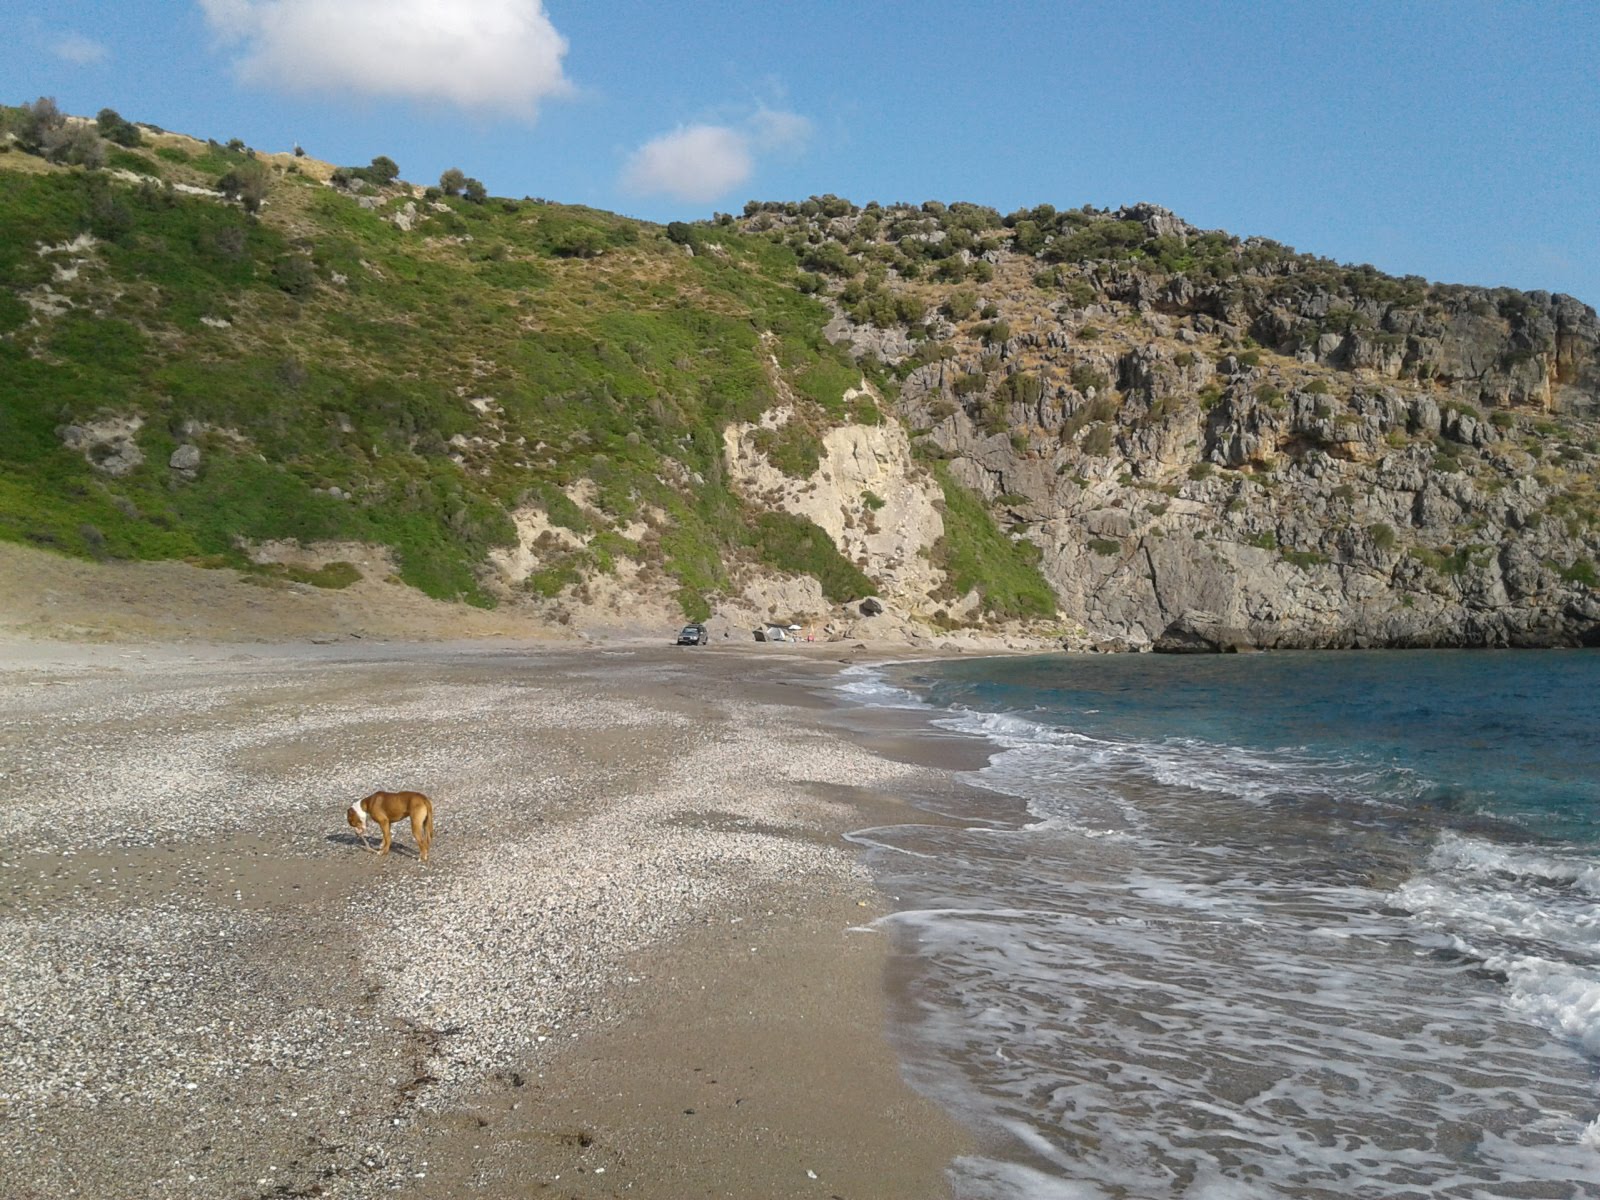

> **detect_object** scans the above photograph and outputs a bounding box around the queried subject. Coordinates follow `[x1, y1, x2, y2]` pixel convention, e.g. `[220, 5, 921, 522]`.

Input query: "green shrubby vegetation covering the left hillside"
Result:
[0, 102, 1049, 616]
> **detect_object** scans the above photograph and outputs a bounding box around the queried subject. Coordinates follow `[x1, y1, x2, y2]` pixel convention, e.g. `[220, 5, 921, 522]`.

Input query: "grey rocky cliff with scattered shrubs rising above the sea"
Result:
[746, 197, 1600, 646]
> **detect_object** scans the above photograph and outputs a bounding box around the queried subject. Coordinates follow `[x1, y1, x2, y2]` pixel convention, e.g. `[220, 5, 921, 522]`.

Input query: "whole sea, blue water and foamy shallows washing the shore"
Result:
[838, 651, 1600, 1200]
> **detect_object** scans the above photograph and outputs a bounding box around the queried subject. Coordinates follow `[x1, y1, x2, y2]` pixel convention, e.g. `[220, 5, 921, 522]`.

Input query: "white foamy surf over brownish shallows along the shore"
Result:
[838, 662, 1600, 1200]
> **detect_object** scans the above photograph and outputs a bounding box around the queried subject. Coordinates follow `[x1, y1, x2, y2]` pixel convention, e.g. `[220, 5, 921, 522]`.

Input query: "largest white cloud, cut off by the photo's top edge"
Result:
[200, 0, 571, 118]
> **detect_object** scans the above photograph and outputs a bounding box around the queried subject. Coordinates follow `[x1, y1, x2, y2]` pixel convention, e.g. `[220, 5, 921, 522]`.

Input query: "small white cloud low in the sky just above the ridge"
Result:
[622, 109, 811, 203]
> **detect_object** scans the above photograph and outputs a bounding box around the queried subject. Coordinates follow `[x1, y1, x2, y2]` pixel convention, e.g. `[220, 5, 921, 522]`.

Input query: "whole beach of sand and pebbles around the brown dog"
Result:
[0, 637, 982, 1197]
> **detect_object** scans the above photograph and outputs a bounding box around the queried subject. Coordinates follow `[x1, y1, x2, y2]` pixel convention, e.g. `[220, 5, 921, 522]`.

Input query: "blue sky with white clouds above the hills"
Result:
[0, 0, 1600, 304]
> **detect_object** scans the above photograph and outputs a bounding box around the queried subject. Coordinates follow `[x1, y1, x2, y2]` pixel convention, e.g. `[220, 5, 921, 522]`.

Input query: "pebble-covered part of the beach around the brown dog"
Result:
[0, 646, 960, 1198]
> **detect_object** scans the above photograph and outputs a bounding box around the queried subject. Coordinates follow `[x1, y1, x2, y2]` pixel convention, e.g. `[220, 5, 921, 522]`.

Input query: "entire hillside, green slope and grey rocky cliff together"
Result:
[0, 106, 1600, 646]
